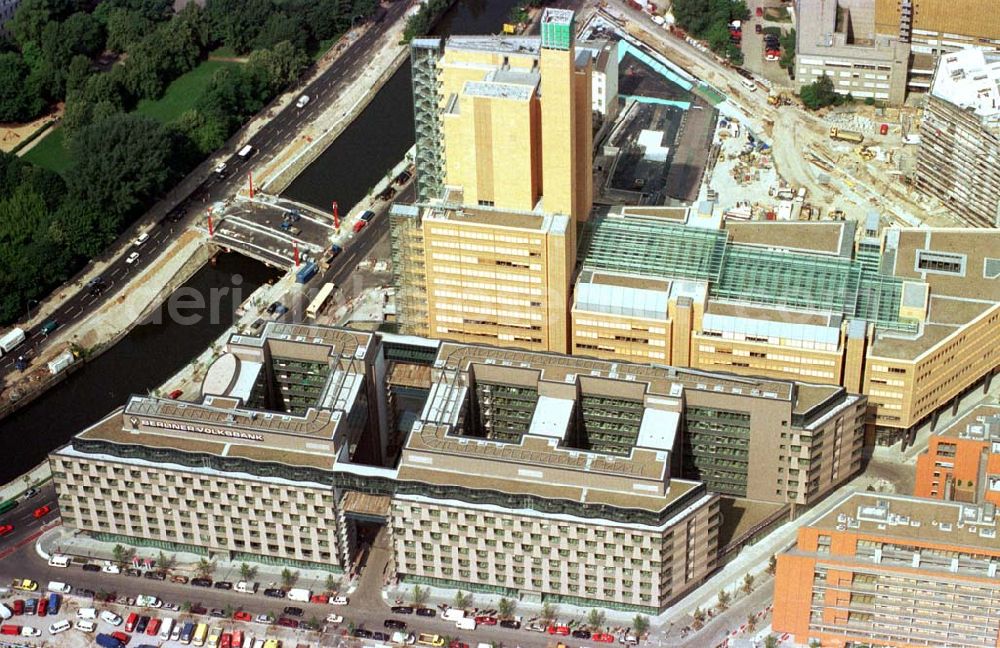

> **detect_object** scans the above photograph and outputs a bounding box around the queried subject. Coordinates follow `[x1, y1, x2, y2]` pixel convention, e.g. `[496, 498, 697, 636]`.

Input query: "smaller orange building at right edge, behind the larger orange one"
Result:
[913, 405, 1000, 504]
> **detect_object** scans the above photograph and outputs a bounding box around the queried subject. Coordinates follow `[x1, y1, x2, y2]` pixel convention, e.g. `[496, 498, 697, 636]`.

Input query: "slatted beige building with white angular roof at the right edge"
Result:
[915, 48, 1000, 227]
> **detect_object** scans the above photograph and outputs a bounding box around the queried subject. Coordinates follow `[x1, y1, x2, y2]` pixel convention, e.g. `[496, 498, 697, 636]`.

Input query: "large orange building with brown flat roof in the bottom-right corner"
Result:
[772, 492, 1000, 648]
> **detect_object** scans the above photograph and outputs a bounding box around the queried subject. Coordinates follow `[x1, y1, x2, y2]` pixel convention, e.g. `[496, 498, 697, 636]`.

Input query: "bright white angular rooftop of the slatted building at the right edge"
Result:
[931, 49, 1000, 129]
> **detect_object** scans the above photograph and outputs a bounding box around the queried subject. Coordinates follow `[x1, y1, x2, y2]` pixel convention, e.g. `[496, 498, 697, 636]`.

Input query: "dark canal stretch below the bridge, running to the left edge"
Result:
[0, 253, 280, 484]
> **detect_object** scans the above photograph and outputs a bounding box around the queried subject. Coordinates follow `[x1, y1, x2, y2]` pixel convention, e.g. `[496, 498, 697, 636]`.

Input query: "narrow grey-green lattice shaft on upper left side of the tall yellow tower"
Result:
[410, 38, 444, 202]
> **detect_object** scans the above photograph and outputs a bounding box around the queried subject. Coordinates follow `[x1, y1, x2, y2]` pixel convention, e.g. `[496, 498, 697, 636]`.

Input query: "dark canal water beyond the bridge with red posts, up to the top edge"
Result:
[282, 0, 516, 211]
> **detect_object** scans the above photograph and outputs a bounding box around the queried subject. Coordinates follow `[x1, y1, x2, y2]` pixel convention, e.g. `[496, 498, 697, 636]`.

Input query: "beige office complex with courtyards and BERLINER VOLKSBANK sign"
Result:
[50, 323, 865, 612]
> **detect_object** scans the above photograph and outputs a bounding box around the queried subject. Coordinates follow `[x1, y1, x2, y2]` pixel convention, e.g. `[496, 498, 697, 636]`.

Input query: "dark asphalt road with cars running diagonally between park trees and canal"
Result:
[0, 2, 409, 376]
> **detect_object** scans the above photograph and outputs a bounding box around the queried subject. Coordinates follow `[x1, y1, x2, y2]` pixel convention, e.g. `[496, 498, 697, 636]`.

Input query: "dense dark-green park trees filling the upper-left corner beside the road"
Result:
[0, 0, 376, 324]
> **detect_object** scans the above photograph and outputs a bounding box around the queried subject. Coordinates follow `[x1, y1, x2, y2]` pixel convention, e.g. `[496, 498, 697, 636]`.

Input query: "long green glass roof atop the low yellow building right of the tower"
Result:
[578, 217, 916, 330]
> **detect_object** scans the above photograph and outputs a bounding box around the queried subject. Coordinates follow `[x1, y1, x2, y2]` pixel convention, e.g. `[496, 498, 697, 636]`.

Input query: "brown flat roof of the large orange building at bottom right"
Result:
[810, 491, 1000, 556]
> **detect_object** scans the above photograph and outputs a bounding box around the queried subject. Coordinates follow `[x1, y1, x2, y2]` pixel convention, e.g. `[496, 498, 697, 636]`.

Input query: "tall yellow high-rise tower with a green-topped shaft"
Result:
[390, 9, 595, 352]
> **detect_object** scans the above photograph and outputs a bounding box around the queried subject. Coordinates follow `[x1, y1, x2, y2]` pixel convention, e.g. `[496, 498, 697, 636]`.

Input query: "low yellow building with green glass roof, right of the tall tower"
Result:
[570, 207, 1000, 444]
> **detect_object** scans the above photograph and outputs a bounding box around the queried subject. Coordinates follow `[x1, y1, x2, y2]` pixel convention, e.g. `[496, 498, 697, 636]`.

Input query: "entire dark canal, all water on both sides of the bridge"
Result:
[0, 0, 528, 484]
